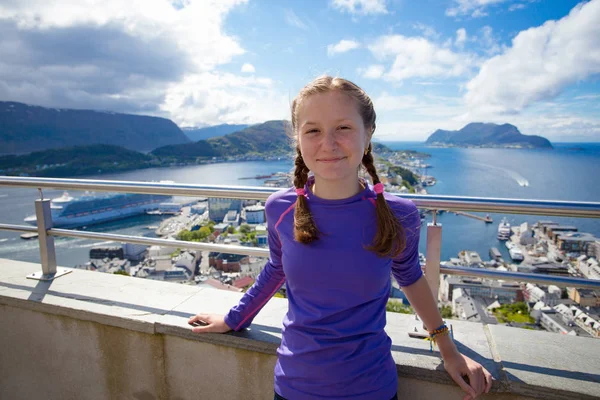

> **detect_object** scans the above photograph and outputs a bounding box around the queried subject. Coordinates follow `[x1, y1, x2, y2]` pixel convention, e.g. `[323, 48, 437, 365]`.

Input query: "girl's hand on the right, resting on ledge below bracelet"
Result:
[444, 352, 494, 400]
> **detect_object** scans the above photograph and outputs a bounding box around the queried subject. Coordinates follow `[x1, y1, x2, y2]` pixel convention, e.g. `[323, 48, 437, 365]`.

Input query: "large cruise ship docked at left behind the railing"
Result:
[25, 192, 171, 228]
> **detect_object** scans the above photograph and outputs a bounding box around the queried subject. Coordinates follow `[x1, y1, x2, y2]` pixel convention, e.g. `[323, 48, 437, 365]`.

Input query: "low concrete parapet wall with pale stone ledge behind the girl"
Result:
[0, 259, 600, 400]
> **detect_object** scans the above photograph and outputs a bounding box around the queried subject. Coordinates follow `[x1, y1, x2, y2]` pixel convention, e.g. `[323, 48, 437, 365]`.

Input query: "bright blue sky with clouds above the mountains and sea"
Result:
[0, 0, 600, 142]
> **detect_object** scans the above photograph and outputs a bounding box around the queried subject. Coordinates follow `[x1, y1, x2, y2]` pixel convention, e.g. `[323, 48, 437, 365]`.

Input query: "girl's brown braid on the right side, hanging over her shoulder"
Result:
[362, 143, 406, 257]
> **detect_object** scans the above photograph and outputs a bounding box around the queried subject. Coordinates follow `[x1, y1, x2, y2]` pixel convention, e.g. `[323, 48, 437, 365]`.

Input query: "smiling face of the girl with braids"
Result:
[296, 90, 371, 182]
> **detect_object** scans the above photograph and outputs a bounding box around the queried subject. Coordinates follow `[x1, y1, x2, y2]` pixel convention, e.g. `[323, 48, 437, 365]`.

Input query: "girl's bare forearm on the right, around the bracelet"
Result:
[402, 276, 457, 358]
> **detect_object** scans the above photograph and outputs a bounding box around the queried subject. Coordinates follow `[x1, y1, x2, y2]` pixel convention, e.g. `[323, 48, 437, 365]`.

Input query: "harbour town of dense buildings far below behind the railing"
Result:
[72, 151, 600, 338]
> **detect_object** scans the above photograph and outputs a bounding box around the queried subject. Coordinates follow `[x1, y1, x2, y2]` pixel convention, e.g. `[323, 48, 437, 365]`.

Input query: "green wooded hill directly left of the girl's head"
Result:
[152, 121, 292, 161]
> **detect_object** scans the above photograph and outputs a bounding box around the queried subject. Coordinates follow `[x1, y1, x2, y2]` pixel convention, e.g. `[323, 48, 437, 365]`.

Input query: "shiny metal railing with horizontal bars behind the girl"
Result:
[0, 176, 600, 292]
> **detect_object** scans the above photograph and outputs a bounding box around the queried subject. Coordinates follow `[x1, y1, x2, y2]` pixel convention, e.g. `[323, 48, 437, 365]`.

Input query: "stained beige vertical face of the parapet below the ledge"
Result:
[0, 305, 525, 400]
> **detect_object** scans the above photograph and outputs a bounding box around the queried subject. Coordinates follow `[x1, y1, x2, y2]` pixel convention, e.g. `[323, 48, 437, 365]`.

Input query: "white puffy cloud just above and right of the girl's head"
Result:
[369, 35, 476, 81]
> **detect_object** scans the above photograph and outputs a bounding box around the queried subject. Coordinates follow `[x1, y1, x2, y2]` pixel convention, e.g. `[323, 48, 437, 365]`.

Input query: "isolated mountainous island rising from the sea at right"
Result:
[425, 122, 552, 149]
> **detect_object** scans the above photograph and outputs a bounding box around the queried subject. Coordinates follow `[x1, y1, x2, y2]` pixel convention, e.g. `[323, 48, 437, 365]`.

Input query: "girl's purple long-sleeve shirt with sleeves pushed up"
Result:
[225, 178, 422, 400]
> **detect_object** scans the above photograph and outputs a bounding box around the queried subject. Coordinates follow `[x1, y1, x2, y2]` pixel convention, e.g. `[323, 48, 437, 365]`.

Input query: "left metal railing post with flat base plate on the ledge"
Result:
[27, 198, 71, 281]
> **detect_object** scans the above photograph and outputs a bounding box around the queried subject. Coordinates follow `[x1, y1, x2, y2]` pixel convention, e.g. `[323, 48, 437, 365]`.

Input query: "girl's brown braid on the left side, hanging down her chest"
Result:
[294, 147, 319, 244]
